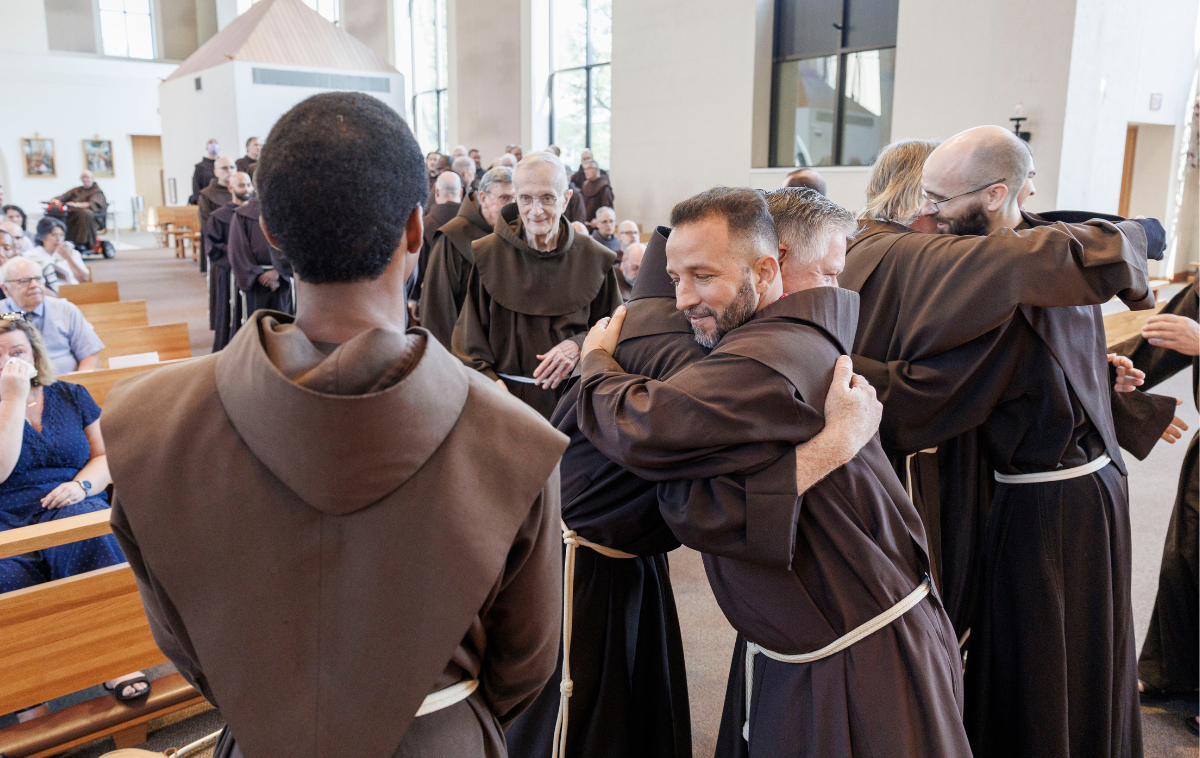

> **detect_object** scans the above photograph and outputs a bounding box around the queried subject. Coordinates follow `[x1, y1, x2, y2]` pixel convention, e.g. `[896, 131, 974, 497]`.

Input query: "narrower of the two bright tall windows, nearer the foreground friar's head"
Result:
[408, 0, 450, 152]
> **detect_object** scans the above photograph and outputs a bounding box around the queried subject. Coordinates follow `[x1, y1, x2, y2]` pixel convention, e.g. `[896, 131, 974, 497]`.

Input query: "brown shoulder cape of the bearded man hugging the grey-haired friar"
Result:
[713, 287, 858, 395]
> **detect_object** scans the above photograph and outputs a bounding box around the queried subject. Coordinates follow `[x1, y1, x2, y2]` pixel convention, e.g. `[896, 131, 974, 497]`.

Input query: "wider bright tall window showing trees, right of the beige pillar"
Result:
[550, 0, 612, 167]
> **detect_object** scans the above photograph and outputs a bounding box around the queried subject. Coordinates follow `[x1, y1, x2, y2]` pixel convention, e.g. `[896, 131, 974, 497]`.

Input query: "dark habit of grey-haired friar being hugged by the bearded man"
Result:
[505, 227, 706, 758]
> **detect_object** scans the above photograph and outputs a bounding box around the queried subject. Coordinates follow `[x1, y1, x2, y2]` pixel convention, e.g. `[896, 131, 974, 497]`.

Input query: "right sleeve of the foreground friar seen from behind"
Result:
[479, 467, 563, 727]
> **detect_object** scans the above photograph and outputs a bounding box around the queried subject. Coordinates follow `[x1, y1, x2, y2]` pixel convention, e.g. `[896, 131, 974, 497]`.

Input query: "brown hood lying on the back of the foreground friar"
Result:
[216, 311, 468, 516]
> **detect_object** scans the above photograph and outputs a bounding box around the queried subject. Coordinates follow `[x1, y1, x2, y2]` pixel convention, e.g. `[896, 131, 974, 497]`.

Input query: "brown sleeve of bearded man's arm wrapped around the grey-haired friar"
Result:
[576, 350, 824, 481]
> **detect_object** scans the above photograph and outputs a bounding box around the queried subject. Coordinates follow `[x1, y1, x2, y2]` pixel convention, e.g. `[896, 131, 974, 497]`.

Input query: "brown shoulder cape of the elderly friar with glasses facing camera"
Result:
[472, 204, 617, 315]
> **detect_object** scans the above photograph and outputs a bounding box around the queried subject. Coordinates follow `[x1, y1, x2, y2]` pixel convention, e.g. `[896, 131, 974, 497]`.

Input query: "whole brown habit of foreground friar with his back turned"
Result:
[104, 312, 566, 758]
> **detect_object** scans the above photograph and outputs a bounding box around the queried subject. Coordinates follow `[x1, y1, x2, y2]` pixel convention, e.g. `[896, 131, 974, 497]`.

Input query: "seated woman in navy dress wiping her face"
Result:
[0, 313, 150, 720]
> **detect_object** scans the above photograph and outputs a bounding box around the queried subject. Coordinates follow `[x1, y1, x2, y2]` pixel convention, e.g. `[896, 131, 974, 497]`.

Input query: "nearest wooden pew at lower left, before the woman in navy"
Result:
[0, 510, 204, 758]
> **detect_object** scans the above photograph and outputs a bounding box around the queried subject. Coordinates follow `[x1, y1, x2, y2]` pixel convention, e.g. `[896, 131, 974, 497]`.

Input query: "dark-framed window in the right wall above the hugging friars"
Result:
[770, 0, 899, 167]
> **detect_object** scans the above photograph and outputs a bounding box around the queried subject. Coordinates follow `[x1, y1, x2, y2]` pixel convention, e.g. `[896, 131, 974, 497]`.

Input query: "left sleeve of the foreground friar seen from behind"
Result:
[109, 494, 217, 705]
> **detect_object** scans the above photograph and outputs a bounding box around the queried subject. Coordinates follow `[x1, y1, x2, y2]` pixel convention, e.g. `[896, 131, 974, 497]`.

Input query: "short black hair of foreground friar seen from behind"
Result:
[254, 92, 430, 284]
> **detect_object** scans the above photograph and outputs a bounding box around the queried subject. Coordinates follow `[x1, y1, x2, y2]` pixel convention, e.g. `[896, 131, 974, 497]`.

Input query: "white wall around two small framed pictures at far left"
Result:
[0, 50, 175, 228]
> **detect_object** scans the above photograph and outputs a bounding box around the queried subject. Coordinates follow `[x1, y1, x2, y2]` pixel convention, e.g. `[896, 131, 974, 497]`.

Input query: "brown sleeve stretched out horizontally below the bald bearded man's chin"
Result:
[888, 221, 1153, 357]
